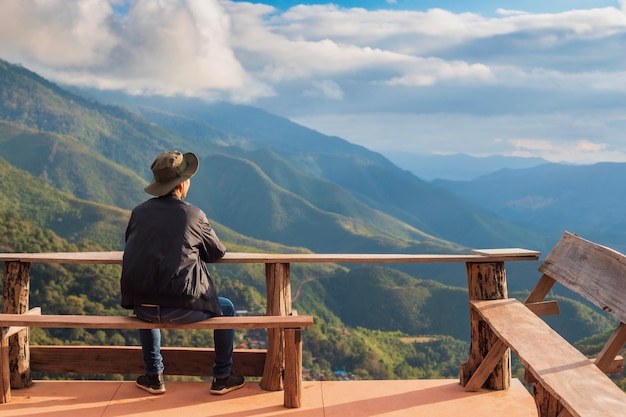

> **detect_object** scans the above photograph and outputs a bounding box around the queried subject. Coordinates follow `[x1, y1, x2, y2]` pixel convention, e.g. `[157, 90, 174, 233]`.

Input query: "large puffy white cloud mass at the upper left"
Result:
[0, 0, 254, 95]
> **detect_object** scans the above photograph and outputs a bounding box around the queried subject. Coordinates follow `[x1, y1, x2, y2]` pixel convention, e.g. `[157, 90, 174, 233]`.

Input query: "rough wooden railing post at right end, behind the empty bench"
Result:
[460, 262, 511, 390]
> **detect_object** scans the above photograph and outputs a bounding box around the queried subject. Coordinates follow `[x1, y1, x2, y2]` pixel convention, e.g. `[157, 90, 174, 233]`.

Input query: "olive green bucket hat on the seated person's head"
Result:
[144, 151, 199, 197]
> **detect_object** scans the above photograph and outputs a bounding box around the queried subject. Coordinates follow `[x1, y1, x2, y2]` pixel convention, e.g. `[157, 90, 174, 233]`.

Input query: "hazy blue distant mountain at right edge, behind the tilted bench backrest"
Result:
[435, 162, 626, 252]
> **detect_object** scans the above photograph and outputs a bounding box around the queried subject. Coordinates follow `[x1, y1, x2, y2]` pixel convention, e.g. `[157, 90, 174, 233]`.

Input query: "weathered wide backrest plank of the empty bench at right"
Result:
[539, 232, 626, 322]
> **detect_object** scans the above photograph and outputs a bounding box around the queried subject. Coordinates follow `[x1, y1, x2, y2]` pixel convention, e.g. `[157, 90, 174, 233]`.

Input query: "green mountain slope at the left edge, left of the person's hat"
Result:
[0, 60, 210, 208]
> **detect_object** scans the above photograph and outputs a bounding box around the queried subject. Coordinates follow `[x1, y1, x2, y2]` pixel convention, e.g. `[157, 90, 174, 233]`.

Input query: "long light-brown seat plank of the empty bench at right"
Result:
[470, 299, 626, 417]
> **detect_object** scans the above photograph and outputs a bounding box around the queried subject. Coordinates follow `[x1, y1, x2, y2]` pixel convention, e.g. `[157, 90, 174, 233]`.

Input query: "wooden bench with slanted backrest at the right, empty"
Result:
[465, 232, 626, 417]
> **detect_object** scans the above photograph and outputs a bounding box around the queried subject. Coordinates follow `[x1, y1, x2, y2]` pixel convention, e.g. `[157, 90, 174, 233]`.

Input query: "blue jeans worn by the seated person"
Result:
[135, 297, 235, 378]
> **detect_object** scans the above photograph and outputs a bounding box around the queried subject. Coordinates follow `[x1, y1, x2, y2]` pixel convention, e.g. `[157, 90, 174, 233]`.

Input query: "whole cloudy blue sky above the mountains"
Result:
[0, 0, 626, 163]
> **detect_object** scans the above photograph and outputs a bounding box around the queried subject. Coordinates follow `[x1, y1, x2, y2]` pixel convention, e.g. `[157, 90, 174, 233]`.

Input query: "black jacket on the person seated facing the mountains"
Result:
[120, 196, 226, 315]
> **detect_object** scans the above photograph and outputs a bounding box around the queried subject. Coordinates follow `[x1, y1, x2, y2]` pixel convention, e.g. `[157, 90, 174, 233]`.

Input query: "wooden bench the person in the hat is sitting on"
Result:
[0, 308, 313, 408]
